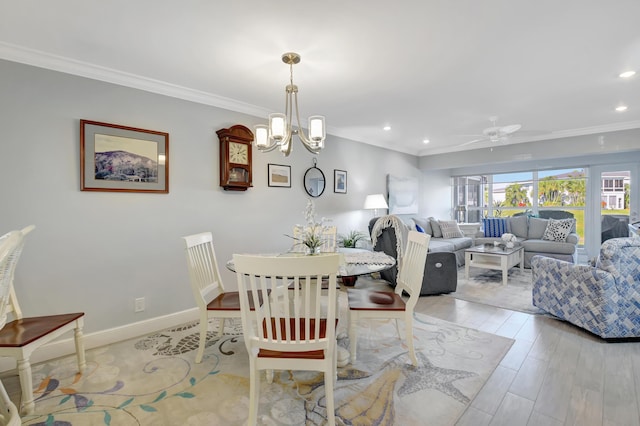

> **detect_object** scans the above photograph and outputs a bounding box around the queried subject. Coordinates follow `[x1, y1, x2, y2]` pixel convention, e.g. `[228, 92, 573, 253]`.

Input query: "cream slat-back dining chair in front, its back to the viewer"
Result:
[233, 254, 339, 425]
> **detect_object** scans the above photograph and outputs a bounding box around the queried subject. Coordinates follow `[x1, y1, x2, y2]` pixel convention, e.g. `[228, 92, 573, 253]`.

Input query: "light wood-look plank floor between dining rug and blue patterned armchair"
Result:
[416, 296, 640, 426]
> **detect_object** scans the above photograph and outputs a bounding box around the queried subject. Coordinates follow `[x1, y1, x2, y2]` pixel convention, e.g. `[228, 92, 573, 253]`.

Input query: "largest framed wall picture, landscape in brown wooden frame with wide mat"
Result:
[80, 120, 169, 194]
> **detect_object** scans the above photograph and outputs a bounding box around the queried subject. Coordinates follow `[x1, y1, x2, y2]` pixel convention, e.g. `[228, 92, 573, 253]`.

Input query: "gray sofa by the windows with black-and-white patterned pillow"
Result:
[474, 216, 579, 268]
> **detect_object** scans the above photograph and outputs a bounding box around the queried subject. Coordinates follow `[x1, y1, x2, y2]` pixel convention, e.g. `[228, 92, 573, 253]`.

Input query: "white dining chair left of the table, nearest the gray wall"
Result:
[182, 232, 250, 364]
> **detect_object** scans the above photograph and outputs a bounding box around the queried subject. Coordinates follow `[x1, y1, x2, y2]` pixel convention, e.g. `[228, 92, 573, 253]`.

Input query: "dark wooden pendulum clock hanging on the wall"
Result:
[216, 124, 253, 191]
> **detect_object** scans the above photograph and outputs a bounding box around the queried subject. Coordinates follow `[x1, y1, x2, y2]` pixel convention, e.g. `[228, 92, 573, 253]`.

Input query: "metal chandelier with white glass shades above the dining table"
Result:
[255, 52, 326, 157]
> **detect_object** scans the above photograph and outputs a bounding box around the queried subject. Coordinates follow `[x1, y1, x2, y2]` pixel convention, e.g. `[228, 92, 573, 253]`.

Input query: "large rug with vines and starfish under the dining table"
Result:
[22, 315, 513, 426]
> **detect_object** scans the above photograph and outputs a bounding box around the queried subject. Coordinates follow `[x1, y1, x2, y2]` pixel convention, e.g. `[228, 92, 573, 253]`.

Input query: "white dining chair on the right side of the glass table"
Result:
[347, 231, 431, 366]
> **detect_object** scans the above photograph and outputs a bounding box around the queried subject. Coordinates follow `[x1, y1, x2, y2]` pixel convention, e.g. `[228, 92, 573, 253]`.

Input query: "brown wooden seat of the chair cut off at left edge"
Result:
[0, 312, 84, 348]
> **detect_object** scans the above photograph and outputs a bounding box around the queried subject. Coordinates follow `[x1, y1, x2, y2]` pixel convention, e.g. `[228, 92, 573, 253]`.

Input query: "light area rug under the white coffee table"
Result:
[448, 267, 545, 314]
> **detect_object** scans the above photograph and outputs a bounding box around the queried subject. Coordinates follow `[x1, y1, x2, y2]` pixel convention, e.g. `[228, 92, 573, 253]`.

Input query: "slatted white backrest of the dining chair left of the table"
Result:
[183, 232, 225, 307]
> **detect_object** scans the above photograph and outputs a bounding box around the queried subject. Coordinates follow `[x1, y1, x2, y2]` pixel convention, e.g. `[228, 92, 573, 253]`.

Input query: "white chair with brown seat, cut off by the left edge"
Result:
[0, 225, 86, 414]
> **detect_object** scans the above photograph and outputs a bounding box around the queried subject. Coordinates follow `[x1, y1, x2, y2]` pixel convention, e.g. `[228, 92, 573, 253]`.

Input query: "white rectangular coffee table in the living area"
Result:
[464, 244, 524, 285]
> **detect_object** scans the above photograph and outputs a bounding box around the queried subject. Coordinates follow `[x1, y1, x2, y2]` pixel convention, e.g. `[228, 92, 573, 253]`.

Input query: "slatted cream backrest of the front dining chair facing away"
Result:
[233, 254, 339, 352]
